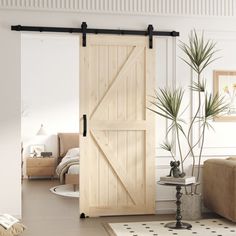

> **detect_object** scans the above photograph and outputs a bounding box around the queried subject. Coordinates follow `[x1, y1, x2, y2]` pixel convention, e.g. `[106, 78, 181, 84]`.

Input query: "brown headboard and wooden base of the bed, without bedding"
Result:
[58, 133, 79, 191]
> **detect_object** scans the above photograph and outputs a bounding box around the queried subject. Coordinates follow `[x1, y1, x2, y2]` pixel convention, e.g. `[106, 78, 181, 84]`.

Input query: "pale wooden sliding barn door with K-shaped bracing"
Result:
[80, 35, 155, 216]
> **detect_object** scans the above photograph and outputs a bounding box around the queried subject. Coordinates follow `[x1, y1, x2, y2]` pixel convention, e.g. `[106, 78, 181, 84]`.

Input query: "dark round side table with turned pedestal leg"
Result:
[157, 181, 192, 229]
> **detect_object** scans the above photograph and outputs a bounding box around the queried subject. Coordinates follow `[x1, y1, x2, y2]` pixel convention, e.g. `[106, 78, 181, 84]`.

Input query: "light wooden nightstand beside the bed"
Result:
[26, 157, 57, 178]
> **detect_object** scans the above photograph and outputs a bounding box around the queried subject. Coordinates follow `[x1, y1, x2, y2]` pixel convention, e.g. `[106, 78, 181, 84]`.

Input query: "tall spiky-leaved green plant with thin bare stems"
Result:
[149, 30, 227, 194]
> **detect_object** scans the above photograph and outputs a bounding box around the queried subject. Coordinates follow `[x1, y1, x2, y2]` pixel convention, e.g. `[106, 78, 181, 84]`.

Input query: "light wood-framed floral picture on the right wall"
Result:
[213, 70, 236, 121]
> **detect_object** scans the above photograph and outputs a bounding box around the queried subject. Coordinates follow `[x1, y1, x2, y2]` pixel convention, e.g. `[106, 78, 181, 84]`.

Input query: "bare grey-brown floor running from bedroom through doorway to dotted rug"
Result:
[22, 179, 214, 236]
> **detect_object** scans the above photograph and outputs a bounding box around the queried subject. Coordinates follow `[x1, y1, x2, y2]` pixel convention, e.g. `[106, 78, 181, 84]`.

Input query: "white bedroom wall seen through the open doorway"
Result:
[21, 33, 79, 177]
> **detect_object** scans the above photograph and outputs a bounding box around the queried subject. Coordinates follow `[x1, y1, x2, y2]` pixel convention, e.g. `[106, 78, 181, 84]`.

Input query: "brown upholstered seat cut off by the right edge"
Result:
[203, 158, 236, 222]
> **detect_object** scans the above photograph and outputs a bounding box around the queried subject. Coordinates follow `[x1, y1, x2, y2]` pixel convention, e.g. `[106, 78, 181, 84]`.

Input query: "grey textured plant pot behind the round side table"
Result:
[181, 194, 202, 220]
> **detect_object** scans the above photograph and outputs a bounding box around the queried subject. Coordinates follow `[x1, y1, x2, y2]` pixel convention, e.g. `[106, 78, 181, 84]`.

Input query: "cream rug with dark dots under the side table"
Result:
[105, 219, 236, 236]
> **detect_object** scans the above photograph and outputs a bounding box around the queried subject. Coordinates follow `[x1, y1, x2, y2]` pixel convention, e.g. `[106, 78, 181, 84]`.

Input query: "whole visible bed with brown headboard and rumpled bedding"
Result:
[56, 133, 79, 190]
